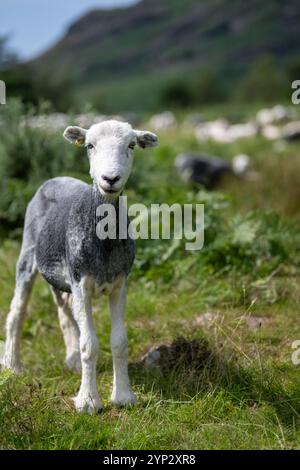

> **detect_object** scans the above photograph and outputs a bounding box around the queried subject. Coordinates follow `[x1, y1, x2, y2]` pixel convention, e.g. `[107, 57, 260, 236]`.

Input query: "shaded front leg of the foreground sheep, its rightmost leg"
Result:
[109, 280, 136, 405]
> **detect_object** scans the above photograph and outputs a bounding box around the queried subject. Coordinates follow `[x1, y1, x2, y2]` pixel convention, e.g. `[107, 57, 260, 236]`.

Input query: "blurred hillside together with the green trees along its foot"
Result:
[0, 0, 299, 113]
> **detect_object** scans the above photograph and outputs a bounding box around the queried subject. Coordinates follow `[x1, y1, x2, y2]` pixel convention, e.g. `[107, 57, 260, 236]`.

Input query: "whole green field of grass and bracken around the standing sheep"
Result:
[0, 104, 300, 449]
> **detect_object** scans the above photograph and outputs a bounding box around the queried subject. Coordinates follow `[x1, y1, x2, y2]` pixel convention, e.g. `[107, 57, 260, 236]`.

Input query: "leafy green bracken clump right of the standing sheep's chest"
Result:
[132, 191, 300, 286]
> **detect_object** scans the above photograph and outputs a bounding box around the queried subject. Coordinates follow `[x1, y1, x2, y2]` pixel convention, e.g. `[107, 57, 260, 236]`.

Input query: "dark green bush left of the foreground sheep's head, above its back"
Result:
[0, 100, 87, 228]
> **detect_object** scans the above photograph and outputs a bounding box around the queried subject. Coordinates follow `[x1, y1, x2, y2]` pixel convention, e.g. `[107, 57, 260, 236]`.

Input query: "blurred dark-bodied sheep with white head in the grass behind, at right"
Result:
[175, 154, 249, 189]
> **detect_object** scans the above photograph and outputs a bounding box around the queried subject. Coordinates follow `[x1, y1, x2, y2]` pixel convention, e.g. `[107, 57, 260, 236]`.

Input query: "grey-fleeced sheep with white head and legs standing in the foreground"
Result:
[2, 120, 157, 412]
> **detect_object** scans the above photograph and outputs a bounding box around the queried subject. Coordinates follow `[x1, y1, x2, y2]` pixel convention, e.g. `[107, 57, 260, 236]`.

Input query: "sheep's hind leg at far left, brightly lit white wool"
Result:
[2, 249, 37, 373]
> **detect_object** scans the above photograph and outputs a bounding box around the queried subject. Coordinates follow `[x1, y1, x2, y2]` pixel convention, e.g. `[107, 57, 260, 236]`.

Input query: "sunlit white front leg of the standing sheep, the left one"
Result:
[72, 279, 102, 413]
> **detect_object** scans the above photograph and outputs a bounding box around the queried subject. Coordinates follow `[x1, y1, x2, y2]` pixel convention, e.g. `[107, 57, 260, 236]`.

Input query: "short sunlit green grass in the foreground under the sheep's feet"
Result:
[0, 243, 300, 449]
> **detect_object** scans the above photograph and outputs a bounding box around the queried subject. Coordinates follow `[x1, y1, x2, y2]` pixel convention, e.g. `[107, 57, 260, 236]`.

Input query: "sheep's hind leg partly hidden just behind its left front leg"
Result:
[52, 289, 81, 372]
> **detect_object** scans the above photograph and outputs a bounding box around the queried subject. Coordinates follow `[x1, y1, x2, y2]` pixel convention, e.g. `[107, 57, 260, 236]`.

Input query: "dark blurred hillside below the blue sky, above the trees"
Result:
[29, 0, 300, 110]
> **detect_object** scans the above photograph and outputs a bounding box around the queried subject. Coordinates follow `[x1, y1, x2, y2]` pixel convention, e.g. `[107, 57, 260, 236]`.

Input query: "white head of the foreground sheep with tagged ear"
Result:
[63, 121, 157, 199]
